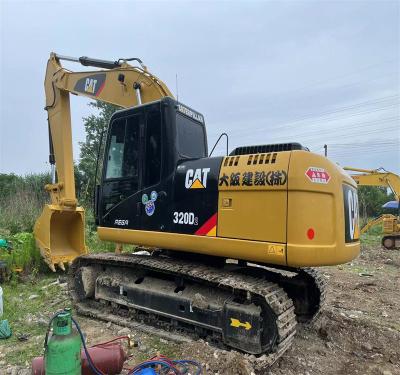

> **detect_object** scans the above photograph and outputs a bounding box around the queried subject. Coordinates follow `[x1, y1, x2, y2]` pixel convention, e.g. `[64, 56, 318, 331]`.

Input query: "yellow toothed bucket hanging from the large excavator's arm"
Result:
[34, 204, 87, 272]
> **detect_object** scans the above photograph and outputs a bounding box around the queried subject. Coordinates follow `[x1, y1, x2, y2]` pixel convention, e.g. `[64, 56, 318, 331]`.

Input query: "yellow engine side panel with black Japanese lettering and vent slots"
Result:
[217, 152, 290, 244]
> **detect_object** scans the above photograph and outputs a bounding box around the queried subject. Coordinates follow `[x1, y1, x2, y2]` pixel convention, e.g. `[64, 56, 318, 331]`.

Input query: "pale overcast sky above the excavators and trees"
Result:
[0, 0, 400, 174]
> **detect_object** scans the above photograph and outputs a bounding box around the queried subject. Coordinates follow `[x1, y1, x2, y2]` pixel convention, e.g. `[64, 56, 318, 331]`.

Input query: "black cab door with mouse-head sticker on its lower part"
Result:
[100, 103, 173, 231]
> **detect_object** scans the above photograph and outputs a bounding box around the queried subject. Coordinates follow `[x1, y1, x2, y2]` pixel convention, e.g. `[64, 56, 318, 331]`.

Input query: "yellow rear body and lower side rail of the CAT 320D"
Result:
[98, 151, 360, 267]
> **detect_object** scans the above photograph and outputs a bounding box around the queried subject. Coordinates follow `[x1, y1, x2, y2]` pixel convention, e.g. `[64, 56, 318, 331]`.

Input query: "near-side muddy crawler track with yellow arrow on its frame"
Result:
[69, 254, 296, 363]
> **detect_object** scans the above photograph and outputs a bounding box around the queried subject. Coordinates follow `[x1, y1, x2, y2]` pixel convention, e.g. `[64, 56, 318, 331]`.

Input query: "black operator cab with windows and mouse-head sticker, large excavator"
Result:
[95, 97, 208, 231]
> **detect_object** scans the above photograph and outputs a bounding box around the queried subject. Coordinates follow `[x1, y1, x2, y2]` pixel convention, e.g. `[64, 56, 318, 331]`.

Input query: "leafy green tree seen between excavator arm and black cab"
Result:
[77, 101, 119, 206]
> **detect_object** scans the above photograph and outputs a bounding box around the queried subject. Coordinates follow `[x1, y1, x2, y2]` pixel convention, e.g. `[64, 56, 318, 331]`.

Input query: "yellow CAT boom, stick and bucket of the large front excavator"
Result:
[34, 53, 173, 271]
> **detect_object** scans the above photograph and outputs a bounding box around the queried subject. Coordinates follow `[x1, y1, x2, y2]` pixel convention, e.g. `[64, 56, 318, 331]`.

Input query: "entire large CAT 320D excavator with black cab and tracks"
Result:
[34, 53, 360, 362]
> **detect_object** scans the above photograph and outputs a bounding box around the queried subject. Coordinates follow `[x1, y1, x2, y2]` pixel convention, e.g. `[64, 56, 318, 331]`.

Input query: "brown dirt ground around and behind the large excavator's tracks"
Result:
[0, 246, 400, 375]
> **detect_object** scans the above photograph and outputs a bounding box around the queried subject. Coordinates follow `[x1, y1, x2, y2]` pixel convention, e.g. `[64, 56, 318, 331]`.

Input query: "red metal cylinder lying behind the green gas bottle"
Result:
[32, 342, 127, 375]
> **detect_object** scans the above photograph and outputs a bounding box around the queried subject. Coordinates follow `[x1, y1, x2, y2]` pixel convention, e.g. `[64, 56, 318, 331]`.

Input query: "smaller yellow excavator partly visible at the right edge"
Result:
[344, 167, 400, 250]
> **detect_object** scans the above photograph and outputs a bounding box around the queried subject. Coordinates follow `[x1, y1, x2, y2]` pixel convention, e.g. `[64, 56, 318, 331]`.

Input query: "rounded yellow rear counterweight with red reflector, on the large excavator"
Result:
[286, 151, 360, 267]
